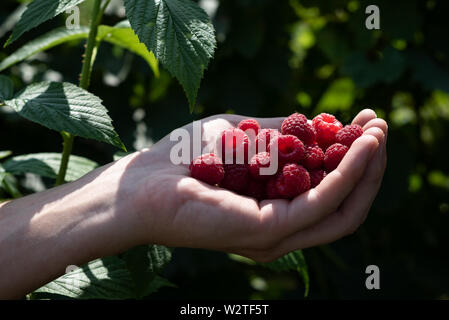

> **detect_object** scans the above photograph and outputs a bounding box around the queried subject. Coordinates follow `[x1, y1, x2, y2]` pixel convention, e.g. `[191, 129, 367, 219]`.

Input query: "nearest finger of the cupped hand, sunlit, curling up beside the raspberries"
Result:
[261, 134, 378, 237]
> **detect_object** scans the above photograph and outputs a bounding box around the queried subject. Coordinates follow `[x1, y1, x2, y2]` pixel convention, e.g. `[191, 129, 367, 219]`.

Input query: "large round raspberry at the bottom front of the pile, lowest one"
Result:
[276, 163, 310, 199]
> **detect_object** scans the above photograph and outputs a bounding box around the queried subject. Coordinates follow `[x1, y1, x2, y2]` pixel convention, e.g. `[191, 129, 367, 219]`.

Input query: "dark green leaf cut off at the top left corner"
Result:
[5, 0, 84, 47]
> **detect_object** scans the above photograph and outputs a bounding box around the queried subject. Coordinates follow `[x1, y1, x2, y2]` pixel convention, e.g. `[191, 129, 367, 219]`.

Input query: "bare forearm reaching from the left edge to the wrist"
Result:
[0, 161, 139, 298]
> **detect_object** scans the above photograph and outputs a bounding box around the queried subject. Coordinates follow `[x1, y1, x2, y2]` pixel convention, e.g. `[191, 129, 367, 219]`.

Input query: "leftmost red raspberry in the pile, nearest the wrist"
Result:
[189, 153, 224, 185]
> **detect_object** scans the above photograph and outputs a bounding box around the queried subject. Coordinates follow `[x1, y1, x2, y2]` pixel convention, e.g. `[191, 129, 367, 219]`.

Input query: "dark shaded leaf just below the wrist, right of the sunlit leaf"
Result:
[123, 245, 171, 298]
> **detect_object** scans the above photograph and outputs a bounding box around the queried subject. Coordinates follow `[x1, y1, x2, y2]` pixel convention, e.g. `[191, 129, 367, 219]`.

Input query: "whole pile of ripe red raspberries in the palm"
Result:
[189, 113, 363, 200]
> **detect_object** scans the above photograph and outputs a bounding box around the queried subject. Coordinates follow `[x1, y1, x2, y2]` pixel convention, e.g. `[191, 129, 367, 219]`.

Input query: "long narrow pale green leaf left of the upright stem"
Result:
[0, 27, 89, 71]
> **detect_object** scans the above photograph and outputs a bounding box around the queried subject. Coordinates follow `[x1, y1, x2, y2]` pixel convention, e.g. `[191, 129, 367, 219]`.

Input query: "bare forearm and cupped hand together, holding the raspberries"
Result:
[0, 109, 388, 299]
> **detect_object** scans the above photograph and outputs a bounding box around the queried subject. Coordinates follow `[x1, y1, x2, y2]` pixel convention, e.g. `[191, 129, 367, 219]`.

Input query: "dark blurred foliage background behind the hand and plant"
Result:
[0, 0, 449, 299]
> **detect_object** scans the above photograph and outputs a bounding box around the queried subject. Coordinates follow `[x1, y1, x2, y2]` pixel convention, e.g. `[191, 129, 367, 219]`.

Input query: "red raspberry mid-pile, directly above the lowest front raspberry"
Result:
[268, 135, 304, 163]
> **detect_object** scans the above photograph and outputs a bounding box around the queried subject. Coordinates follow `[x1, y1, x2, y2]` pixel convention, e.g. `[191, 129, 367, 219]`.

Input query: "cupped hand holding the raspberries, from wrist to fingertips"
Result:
[117, 109, 388, 262]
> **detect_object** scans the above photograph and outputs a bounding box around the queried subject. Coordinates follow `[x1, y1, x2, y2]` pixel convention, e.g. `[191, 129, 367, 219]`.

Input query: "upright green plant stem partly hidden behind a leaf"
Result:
[55, 0, 103, 186]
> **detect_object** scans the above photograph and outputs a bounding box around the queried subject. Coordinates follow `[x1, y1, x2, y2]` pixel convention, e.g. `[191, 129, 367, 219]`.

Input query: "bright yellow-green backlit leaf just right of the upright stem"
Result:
[97, 21, 159, 78]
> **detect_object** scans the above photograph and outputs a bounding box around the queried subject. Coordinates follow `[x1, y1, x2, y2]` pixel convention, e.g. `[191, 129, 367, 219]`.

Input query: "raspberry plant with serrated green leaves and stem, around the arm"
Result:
[0, 0, 308, 299]
